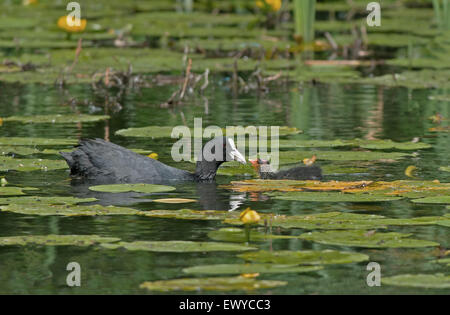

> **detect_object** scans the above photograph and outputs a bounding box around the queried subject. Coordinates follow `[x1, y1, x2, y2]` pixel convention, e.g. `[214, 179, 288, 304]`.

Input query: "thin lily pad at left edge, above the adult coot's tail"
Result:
[3, 114, 109, 124]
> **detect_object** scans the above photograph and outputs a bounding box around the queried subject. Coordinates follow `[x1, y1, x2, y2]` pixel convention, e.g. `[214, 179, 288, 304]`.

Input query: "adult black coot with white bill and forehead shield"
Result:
[61, 137, 245, 183]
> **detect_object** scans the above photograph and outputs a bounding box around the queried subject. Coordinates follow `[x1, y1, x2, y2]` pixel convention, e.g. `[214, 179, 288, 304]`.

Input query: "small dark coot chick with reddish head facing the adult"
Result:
[250, 159, 322, 180]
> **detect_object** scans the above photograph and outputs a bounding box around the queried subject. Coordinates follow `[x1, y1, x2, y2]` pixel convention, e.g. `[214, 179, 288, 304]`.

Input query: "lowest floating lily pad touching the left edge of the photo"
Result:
[0, 235, 120, 246]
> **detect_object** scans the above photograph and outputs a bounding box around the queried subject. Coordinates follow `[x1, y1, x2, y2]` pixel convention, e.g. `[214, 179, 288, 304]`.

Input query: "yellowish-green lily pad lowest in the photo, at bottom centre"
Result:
[139, 277, 287, 292]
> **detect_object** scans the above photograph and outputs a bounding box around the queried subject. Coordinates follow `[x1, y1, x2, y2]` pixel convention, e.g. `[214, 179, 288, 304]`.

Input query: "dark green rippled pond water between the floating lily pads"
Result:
[0, 78, 450, 294]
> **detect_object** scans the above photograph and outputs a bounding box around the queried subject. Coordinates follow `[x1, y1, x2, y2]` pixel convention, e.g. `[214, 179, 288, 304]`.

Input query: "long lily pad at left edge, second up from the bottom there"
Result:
[0, 205, 140, 216]
